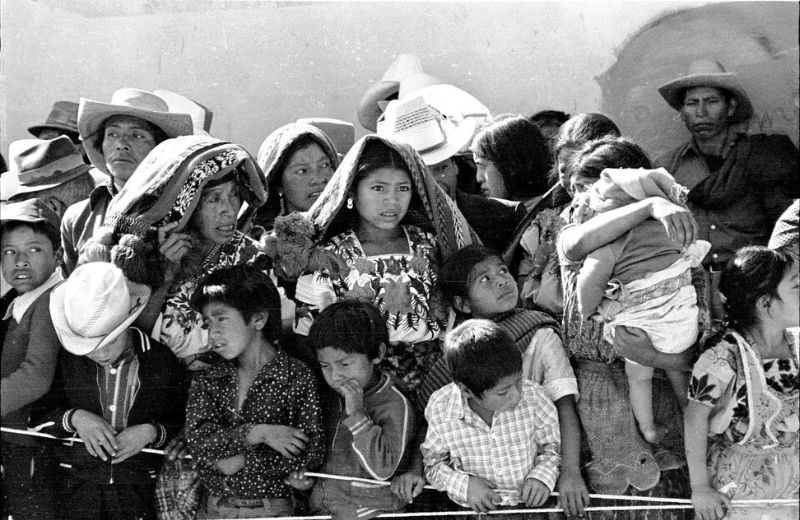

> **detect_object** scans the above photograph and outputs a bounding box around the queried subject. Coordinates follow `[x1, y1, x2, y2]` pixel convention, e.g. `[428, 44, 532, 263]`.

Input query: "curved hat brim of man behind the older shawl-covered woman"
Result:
[78, 98, 194, 175]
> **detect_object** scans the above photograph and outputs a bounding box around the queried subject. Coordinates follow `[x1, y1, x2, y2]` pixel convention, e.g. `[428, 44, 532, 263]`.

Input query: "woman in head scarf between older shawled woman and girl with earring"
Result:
[254, 123, 339, 232]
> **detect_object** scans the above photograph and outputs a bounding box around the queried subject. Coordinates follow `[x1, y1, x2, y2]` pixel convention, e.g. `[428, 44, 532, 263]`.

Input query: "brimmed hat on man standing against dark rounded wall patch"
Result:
[658, 59, 753, 121]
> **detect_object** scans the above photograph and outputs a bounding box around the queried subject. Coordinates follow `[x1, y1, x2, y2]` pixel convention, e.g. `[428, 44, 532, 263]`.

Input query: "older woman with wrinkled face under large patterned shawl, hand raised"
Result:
[104, 136, 268, 368]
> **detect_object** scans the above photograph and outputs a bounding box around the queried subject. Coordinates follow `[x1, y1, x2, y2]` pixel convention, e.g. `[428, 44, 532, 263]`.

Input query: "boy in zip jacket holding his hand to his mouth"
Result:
[298, 301, 415, 520]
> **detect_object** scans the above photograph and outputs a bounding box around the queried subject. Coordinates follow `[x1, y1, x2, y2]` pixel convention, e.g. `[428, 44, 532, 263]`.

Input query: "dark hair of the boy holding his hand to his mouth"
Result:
[308, 300, 389, 360]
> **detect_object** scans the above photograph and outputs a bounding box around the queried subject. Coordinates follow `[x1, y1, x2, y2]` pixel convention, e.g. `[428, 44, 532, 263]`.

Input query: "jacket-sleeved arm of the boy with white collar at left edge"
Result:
[0, 295, 61, 416]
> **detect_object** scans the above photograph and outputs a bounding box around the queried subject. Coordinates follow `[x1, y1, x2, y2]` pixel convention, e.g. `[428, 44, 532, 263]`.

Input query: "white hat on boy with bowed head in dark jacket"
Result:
[50, 262, 150, 356]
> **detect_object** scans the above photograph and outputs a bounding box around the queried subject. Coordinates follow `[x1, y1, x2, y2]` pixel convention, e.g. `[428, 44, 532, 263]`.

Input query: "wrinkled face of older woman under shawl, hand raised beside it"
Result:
[190, 180, 242, 244]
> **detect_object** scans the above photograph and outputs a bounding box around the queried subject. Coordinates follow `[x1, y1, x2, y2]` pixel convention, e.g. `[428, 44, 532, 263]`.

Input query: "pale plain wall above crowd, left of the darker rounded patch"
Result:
[0, 0, 716, 156]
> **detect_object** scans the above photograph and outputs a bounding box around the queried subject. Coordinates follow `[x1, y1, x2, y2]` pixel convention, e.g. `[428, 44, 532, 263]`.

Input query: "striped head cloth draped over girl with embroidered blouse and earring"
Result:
[308, 135, 480, 256]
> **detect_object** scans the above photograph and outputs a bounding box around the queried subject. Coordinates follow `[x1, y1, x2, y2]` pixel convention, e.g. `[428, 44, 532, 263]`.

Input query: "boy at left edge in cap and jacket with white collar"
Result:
[0, 199, 61, 519]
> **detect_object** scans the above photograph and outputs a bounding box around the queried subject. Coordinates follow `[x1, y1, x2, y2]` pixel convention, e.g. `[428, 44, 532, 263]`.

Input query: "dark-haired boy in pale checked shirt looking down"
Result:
[421, 320, 561, 513]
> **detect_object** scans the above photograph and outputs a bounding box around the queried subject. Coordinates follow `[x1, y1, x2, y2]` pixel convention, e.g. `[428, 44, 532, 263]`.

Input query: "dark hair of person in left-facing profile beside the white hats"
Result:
[472, 116, 550, 200]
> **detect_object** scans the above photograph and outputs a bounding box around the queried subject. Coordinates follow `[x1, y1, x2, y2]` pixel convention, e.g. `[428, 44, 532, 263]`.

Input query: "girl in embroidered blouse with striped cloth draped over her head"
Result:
[296, 136, 474, 390]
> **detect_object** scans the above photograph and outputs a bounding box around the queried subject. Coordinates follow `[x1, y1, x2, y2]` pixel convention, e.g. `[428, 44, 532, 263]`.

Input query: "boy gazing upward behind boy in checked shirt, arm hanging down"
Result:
[419, 245, 589, 516]
